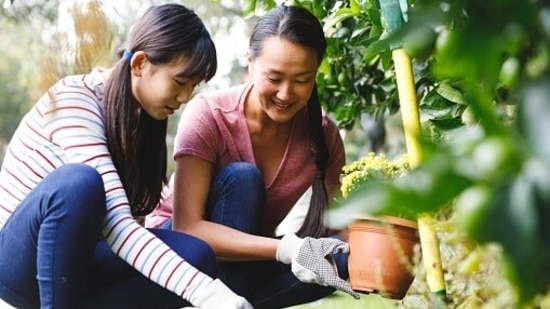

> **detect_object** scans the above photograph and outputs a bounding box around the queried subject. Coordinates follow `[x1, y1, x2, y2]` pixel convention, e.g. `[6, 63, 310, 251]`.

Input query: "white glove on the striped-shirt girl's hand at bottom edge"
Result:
[189, 279, 254, 309]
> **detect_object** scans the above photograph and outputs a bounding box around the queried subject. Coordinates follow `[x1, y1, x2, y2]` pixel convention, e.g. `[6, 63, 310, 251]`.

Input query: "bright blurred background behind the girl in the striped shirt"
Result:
[0, 0, 254, 169]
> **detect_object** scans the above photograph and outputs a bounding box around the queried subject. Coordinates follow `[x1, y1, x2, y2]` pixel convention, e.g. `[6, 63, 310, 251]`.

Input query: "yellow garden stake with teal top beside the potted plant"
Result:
[379, 0, 447, 308]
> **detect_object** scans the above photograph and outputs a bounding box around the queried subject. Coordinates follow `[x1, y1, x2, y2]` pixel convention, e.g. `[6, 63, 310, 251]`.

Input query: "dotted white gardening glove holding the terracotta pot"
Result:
[276, 234, 359, 299]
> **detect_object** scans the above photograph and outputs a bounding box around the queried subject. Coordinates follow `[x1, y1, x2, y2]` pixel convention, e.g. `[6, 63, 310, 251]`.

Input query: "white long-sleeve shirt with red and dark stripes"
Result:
[0, 68, 212, 300]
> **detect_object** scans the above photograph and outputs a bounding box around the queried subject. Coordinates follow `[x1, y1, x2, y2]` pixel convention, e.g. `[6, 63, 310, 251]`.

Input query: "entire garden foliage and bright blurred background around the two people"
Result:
[0, 0, 550, 308]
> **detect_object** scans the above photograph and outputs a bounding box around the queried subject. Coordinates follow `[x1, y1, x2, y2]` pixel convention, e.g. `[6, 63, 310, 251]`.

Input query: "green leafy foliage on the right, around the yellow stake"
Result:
[245, 0, 550, 308]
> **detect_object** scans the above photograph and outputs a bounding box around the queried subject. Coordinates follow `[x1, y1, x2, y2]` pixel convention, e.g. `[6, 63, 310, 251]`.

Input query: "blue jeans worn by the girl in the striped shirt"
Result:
[0, 164, 217, 309]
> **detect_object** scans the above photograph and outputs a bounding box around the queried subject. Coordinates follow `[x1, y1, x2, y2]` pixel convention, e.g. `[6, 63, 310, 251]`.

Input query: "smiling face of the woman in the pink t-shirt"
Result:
[249, 36, 317, 123]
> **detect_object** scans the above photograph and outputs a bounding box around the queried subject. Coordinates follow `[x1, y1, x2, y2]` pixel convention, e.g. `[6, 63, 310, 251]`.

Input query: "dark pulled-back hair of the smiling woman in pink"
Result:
[249, 5, 328, 237]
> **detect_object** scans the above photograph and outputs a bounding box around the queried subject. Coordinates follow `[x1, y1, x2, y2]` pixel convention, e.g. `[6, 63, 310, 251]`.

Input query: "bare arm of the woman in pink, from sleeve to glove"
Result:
[173, 155, 279, 261]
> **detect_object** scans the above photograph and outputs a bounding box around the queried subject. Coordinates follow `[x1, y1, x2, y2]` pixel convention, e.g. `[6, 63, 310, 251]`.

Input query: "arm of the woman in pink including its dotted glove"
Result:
[173, 137, 358, 298]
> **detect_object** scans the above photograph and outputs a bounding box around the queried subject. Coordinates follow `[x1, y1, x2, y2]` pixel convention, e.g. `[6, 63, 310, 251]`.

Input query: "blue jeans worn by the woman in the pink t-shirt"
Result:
[163, 162, 348, 309]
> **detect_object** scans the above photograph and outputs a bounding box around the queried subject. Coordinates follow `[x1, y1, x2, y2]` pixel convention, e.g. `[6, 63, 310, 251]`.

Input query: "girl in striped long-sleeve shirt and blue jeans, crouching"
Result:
[0, 4, 251, 309]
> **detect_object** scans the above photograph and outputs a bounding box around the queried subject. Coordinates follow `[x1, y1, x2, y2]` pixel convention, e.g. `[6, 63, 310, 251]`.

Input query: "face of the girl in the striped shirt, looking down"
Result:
[131, 52, 199, 120]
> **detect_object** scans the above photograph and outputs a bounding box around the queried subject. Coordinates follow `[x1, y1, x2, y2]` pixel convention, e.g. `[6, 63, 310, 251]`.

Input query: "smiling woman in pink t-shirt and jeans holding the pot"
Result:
[146, 6, 358, 308]
